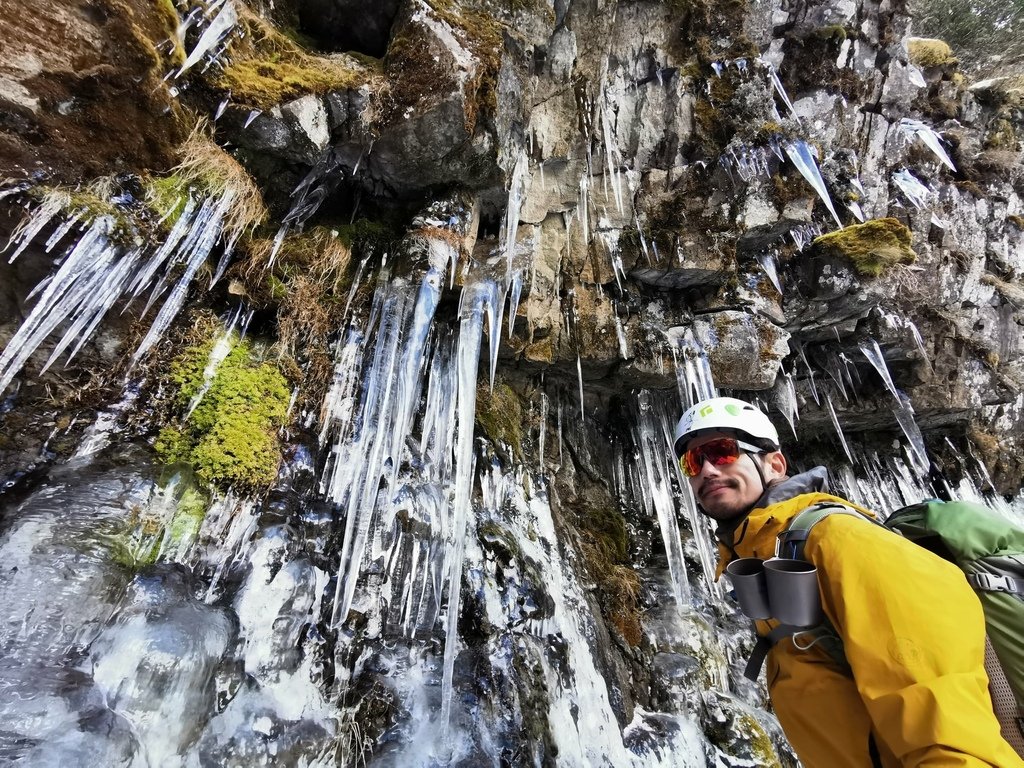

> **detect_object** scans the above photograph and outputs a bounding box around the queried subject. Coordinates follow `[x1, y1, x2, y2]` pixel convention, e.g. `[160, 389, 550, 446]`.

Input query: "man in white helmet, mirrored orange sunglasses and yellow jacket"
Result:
[675, 397, 1024, 768]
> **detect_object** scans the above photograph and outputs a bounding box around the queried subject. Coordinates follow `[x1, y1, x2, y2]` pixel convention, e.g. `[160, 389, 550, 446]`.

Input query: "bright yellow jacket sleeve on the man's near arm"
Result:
[805, 515, 1024, 768]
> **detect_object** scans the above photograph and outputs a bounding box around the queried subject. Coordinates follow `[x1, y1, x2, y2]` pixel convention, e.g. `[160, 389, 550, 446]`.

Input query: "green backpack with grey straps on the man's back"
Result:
[781, 500, 1024, 755]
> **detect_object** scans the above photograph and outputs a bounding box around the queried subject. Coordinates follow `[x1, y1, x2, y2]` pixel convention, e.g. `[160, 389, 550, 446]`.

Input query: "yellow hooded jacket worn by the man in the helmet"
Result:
[719, 471, 1024, 768]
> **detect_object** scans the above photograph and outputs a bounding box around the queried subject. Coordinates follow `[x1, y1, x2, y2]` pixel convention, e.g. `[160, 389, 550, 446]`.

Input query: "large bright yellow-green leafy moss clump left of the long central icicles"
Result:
[155, 333, 290, 490]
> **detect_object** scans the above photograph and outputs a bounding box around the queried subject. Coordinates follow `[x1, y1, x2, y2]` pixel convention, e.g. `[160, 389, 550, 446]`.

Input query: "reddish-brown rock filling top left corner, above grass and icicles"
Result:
[0, 0, 183, 183]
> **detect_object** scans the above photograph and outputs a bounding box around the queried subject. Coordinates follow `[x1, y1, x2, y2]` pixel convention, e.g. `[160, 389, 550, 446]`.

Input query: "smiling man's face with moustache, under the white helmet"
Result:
[686, 432, 785, 522]
